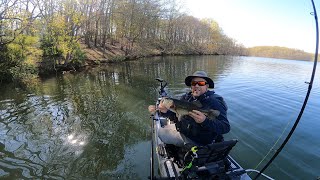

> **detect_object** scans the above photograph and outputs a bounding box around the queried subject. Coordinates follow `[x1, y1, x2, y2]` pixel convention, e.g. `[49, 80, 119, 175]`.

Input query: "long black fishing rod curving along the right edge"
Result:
[254, 0, 319, 180]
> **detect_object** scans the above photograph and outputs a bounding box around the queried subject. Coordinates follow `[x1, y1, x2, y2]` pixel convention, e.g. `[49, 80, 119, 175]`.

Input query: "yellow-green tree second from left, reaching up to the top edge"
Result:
[41, 0, 85, 70]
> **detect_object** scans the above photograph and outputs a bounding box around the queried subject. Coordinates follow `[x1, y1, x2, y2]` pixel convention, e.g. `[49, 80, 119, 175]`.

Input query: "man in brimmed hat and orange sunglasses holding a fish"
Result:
[149, 71, 230, 147]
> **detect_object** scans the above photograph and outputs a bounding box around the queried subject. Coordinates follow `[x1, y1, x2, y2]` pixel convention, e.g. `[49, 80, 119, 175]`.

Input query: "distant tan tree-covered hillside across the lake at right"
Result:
[248, 46, 314, 61]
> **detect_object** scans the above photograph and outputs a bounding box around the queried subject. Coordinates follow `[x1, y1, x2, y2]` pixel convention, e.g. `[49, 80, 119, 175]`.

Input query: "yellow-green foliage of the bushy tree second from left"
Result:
[41, 8, 86, 73]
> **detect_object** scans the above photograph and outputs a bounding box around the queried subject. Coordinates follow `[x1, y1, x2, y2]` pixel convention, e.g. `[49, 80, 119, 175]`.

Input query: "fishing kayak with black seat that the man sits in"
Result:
[149, 79, 273, 180]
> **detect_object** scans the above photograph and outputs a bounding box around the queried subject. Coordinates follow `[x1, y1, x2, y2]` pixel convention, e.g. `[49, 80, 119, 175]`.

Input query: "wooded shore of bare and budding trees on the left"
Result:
[0, 0, 316, 84]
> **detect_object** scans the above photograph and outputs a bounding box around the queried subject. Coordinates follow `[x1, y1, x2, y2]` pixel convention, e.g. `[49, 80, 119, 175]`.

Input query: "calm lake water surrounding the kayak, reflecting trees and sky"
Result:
[0, 56, 320, 179]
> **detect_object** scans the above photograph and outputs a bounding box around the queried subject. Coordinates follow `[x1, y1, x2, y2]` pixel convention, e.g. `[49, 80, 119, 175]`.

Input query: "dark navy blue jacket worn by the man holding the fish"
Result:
[170, 91, 230, 145]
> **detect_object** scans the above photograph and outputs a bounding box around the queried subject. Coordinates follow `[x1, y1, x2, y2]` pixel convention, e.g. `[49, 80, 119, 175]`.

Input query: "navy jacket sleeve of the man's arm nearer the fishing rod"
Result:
[200, 96, 230, 134]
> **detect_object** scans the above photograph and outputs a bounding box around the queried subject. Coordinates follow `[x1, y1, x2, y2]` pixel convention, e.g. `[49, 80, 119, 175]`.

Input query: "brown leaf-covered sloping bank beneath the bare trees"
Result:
[80, 42, 223, 66]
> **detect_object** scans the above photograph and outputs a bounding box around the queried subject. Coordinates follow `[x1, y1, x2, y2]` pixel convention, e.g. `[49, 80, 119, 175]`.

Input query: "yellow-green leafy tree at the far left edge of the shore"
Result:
[0, 0, 41, 83]
